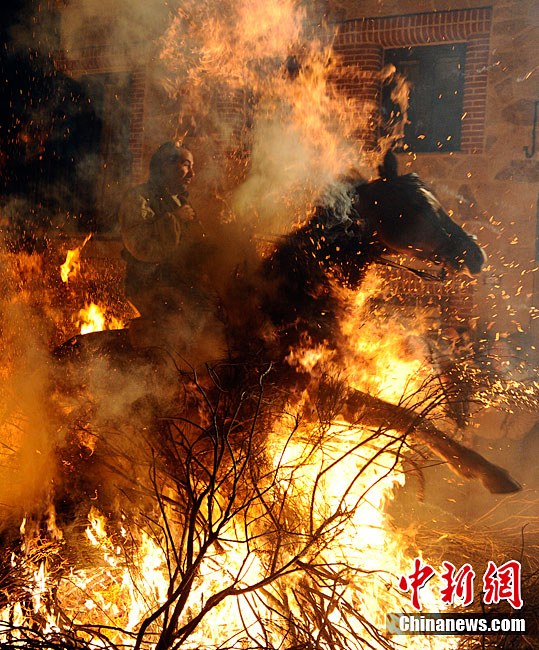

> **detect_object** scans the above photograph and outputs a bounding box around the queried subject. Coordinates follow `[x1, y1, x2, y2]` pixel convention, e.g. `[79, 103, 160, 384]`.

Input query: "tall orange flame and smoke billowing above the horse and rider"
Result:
[161, 0, 376, 234]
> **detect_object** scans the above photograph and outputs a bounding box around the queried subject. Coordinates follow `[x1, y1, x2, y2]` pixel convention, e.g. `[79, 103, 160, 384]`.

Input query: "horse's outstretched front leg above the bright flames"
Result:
[342, 388, 522, 494]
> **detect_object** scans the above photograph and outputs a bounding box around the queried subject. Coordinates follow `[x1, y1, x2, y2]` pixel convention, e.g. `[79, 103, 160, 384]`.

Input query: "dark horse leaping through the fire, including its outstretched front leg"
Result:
[55, 153, 520, 493]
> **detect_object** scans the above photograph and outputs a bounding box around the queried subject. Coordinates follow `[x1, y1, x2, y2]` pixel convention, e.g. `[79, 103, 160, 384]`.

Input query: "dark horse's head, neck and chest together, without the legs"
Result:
[255, 152, 486, 362]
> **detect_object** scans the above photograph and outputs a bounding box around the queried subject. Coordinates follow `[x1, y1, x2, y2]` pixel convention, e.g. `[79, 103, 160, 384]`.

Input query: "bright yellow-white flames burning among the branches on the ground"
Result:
[0, 417, 458, 650]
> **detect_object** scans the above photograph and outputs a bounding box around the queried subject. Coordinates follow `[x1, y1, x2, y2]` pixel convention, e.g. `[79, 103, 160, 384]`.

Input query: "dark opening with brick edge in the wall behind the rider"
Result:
[0, 63, 131, 242]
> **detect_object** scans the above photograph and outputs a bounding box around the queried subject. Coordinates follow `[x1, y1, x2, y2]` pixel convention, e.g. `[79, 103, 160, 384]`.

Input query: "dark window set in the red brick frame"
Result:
[382, 43, 466, 152]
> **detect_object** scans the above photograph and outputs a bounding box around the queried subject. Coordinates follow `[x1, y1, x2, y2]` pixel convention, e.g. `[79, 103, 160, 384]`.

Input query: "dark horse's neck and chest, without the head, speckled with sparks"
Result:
[227, 213, 378, 360]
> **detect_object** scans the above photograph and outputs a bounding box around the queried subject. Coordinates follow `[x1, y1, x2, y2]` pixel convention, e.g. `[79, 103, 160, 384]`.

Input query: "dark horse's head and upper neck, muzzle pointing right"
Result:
[310, 168, 486, 286]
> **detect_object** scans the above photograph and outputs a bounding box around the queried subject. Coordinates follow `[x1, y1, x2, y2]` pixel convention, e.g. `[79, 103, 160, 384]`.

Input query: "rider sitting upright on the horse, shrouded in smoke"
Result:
[119, 142, 217, 346]
